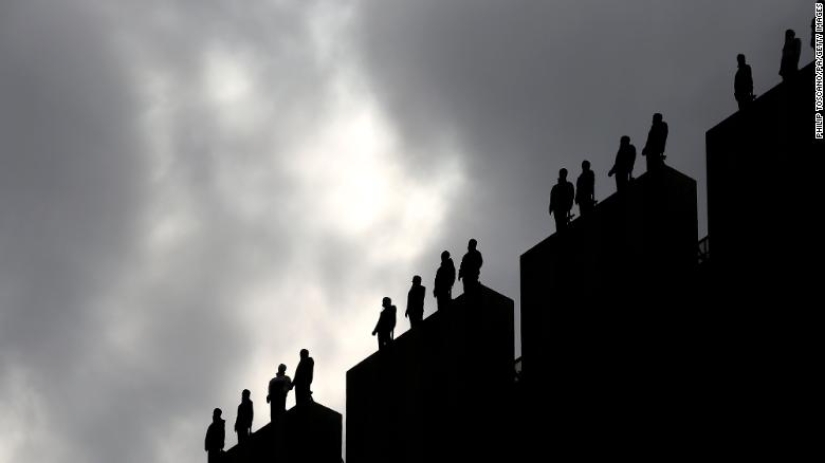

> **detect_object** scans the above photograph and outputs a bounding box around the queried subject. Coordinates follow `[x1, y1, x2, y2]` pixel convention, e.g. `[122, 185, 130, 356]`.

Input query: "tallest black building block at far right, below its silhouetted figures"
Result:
[706, 64, 825, 459]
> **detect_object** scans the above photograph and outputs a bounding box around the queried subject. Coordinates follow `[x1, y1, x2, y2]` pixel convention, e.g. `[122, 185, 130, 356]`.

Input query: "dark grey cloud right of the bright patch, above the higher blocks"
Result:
[355, 0, 812, 348]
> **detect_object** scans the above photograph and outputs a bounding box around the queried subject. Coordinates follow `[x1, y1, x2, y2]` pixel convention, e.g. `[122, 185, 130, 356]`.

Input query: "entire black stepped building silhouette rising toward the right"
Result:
[195, 31, 825, 463]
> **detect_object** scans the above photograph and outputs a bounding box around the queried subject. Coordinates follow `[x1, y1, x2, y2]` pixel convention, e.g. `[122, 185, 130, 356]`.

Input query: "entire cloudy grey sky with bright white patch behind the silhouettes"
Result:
[0, 0, 813, 463]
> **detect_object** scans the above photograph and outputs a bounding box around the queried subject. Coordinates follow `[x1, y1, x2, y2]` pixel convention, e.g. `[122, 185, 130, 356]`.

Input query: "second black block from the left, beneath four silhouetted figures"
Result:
[346, 285, 513, 463]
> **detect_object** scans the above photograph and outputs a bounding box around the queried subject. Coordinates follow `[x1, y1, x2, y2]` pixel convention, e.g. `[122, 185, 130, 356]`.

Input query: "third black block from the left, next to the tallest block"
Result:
[520, 166, 698, 458]
